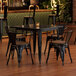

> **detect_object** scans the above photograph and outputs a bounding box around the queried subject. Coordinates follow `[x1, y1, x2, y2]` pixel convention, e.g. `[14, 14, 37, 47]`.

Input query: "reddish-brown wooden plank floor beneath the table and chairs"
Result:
[0, 25, 76, 76]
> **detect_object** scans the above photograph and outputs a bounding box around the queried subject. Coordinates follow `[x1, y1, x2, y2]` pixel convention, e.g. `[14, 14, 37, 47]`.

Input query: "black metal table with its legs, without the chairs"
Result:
[10, 24, 62, 64]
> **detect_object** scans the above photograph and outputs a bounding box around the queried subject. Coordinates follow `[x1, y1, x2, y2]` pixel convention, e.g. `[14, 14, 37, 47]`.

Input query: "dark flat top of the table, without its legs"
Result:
[10, 25, 62, 32]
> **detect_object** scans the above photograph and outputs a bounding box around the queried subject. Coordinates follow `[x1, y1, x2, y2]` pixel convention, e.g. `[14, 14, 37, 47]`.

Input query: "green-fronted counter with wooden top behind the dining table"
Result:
[0, 9, 55, 36]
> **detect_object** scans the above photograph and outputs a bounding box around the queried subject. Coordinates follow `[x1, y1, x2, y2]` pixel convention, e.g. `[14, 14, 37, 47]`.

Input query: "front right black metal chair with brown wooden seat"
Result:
[46, 30, 72, 65]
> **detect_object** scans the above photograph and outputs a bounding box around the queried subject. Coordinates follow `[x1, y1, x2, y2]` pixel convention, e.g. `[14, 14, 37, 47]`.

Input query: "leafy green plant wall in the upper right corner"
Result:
[56, 0, 72, 23]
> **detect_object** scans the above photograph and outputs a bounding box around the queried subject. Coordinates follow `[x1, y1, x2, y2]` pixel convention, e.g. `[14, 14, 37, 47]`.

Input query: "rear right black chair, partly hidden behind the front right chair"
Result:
[44, 24, 65, 54]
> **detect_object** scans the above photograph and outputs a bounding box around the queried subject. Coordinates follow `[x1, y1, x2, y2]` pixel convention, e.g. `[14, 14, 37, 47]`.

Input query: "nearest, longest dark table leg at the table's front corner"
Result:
[38, 31, 42, 64]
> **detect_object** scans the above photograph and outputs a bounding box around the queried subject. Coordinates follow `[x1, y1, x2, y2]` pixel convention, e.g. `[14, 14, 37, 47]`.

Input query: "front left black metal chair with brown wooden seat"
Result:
[7, 31, 34, 66]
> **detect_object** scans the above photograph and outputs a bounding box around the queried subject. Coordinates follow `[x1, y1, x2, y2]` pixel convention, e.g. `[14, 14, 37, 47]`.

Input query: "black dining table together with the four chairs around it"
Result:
[0, 15, 72, 66]
